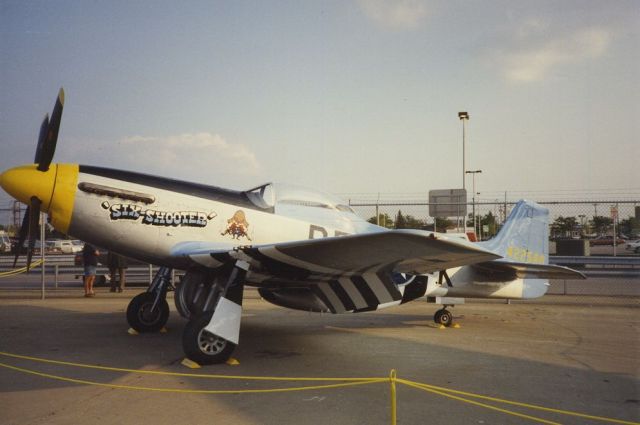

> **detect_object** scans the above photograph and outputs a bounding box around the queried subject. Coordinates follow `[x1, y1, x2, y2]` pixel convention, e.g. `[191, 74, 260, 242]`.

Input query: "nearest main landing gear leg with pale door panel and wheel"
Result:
[182, 261, 249, 364]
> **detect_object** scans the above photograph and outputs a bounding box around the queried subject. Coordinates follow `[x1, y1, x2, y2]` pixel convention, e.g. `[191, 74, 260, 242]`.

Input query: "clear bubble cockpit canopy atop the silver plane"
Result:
[245, 183, 376, 236]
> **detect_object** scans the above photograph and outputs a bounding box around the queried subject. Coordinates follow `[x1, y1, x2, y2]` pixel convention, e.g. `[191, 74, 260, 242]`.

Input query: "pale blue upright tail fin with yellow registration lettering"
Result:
[479, 200, 549, 264]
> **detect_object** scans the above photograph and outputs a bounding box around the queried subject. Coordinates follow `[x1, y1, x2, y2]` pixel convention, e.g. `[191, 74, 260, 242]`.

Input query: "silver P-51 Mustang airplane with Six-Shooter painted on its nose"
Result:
[0, 89, 584, 363]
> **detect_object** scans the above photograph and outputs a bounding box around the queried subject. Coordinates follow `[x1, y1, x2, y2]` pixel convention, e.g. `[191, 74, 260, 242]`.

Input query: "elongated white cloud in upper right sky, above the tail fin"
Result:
[500, 27, 612, 82]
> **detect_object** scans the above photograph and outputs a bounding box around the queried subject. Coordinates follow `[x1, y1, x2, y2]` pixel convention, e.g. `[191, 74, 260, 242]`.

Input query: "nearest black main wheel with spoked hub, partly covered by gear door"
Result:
[182, 314, 236, 364]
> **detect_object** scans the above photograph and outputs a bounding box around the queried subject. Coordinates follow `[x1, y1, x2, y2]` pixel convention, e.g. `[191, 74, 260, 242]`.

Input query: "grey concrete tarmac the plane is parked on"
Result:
[0, 289, 640, 425]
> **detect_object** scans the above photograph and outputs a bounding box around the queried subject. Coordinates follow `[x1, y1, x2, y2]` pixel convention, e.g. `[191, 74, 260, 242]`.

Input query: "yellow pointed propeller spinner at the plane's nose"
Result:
[0, 164, 57, 212]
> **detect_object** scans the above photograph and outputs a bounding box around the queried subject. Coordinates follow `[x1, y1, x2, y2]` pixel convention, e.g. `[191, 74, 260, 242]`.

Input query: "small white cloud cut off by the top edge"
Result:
[358, 0, 428, 30]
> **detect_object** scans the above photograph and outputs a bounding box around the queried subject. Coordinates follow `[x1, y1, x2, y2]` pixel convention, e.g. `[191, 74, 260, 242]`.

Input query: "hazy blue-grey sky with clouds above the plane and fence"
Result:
[0, 0, 640, 207]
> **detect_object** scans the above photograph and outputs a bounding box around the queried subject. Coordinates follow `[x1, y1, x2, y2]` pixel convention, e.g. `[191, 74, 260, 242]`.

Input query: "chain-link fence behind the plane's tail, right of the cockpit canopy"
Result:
[349, 200, 640, 296]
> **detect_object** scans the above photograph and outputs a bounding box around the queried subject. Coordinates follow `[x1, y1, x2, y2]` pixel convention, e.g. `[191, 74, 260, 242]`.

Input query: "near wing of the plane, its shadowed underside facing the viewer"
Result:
[199, 230, 500, 277]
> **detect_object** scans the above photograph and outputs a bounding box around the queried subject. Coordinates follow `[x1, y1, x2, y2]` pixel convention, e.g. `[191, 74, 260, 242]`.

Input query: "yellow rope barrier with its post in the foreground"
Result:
[0, 351, 640, 425]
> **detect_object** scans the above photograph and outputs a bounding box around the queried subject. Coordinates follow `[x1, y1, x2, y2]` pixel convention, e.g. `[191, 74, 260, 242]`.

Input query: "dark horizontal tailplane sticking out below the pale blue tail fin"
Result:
[473, 260, 587, 279]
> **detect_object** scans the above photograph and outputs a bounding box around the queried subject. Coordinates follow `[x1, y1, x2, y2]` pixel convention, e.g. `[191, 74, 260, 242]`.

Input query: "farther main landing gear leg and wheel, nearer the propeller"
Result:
[127, 267, 171, 333]
